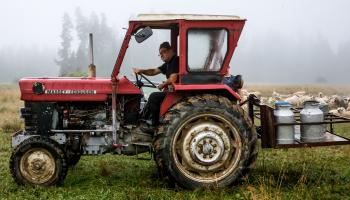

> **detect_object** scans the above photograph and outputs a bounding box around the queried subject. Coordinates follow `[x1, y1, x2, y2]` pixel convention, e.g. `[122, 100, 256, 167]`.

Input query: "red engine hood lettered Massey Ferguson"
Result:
[19, 76, 141, 101]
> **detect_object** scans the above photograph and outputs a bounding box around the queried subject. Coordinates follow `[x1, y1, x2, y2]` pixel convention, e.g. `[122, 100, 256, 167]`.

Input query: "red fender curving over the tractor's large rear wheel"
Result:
[159, 84, 241, 117]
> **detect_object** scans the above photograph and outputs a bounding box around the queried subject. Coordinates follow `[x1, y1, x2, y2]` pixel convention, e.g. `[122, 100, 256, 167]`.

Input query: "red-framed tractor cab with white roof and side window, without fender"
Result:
[111, 14, 245, 94]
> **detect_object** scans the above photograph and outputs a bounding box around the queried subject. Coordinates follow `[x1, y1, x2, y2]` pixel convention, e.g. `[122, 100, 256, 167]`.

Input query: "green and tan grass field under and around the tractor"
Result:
[0, 85, 350, 200]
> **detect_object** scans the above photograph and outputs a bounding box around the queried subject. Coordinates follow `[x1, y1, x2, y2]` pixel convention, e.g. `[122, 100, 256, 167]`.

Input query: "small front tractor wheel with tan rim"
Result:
[10, 137, 68, 186]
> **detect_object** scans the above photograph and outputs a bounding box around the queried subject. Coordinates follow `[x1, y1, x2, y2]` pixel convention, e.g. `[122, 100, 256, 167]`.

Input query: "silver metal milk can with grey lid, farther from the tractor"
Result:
[300, 101, 325, 142]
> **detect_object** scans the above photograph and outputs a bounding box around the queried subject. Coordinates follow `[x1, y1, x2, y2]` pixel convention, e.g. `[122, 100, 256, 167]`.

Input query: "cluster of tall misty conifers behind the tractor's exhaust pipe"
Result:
[55, 8, 119, 76]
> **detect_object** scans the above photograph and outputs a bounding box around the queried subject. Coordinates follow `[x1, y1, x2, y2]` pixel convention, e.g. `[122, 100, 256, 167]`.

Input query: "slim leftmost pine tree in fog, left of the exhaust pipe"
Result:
[55, 13, 73, 76]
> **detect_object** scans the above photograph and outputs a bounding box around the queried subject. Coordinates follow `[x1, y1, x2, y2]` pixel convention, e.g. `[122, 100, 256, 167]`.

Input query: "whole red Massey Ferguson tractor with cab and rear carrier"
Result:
[10, 15, 349, 189]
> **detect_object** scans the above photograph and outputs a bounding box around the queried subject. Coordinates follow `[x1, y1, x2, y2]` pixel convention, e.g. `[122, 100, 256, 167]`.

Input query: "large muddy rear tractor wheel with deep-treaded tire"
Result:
[154, 95, 257, 189]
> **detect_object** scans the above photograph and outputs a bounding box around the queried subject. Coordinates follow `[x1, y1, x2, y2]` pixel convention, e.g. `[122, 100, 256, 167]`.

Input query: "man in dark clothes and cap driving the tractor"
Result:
[133, 42, 179, 134]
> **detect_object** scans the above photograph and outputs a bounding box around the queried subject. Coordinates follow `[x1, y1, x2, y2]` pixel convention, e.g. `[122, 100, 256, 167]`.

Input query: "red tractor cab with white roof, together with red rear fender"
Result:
[111, 14, 245, 120]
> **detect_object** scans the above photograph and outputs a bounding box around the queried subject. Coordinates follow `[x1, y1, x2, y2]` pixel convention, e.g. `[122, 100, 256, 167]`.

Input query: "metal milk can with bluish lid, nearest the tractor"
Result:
[273, 102, 295, 144]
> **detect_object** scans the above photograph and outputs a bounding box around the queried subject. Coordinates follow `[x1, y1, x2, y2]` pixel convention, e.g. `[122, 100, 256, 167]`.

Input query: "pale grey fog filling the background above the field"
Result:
[0, 0, 350, 84]
